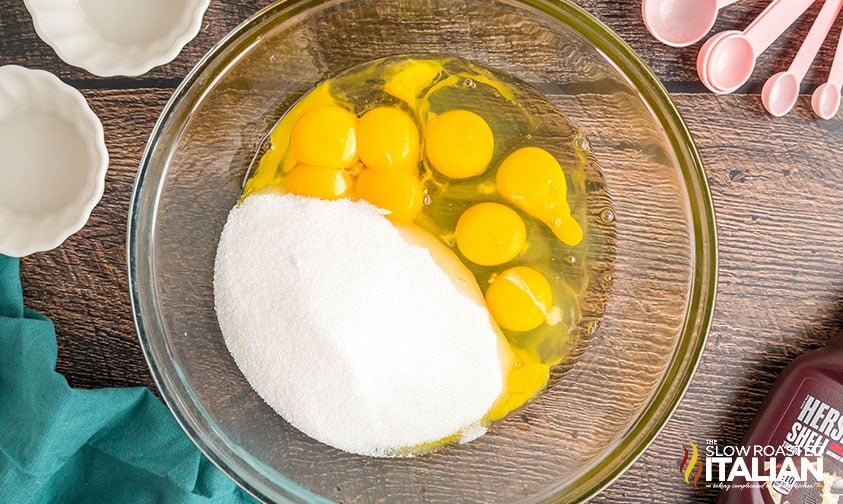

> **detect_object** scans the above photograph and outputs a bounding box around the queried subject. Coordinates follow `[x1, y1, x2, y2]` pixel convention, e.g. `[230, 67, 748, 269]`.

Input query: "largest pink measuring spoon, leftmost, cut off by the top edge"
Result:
[641, 0, 738, 47]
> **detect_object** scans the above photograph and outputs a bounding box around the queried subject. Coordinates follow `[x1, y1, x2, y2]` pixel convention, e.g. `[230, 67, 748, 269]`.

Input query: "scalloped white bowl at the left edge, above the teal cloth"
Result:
[0, 65, 108, 257]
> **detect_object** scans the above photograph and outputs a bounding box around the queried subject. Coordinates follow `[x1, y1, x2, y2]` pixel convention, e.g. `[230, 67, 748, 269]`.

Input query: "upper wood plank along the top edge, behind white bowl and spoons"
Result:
[0, 0, 843, 93]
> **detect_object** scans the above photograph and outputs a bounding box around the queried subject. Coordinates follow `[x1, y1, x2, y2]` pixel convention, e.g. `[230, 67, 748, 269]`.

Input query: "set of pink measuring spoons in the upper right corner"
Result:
[641, 0, 843, 119]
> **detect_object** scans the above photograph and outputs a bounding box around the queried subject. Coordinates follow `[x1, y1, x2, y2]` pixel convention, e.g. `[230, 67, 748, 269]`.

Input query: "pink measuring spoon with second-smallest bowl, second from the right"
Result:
[761, 0, 843, 117]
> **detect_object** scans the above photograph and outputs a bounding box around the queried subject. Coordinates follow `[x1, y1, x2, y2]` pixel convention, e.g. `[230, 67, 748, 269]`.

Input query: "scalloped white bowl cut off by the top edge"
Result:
[24, 0, 210, 77]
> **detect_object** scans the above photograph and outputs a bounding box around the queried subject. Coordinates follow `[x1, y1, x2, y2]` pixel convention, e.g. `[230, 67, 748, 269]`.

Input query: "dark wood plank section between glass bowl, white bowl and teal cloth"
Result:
[21, 89, 171, 387]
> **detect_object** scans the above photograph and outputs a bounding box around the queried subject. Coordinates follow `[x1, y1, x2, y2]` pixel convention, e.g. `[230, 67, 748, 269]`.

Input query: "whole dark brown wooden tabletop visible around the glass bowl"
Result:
[0, 0, 843, 503]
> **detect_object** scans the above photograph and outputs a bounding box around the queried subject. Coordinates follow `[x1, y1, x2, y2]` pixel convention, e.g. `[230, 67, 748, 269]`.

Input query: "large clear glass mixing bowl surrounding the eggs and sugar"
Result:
[128, 0, 717, 503]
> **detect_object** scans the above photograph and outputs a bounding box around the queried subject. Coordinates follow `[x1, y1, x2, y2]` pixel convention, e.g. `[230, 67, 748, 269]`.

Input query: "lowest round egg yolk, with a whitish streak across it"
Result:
[486, 266, 553, 332]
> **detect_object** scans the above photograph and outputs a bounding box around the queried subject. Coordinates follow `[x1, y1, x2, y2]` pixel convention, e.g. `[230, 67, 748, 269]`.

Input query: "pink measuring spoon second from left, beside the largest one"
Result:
[697, 0, 815, 94]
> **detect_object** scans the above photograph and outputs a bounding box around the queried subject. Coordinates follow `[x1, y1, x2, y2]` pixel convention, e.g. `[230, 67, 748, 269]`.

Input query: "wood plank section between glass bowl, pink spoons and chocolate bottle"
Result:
[594, 95, 843, 504]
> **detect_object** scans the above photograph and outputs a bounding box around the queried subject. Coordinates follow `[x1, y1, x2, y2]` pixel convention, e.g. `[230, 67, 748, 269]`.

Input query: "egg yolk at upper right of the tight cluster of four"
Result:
[357, 107, 419, 175]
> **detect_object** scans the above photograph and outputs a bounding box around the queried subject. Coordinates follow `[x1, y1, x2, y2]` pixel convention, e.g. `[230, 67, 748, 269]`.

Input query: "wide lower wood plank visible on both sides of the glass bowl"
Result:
[9, 89, 843, 503]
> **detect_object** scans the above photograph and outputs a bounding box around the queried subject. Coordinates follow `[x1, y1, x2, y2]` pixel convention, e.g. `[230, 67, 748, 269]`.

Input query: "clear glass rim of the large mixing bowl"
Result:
[127, 0, 718, 502]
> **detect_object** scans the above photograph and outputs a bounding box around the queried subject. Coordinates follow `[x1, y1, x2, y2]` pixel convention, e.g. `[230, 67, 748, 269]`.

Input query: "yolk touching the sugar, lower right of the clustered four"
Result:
[354, 168, 424, 223]
